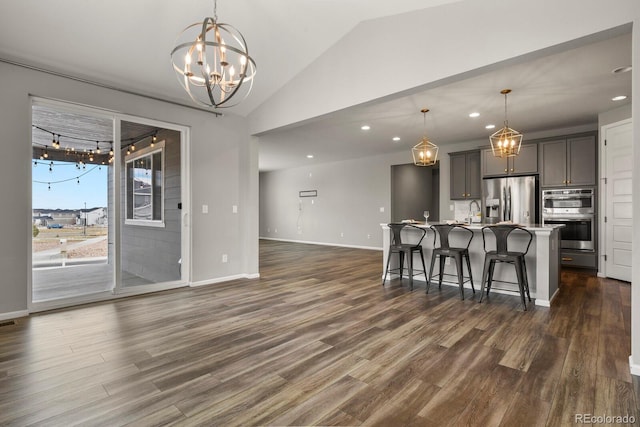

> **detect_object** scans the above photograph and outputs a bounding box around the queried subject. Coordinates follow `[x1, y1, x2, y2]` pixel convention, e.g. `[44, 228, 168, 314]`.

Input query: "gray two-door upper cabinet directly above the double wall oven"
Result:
[540, 134, 596, 187]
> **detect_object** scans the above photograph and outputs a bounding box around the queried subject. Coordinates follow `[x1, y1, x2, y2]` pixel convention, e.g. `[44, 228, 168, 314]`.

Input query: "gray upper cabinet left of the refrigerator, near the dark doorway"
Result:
[449, 150, 482, 200]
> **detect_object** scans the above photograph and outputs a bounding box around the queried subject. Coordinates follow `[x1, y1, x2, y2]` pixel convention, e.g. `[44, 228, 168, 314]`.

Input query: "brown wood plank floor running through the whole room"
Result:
[0, 241, 640, 426]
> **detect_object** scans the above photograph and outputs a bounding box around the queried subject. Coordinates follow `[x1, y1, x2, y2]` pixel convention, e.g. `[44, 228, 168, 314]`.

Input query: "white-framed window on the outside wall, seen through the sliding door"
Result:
[126, 141, 164, 227]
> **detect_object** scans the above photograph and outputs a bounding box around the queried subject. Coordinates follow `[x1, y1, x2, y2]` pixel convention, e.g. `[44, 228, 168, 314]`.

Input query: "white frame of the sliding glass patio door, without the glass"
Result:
[25, 96, 192, 313]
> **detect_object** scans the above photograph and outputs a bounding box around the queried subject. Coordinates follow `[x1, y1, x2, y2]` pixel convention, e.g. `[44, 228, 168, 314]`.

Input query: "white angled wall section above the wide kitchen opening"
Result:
[250, 0, 640, 134]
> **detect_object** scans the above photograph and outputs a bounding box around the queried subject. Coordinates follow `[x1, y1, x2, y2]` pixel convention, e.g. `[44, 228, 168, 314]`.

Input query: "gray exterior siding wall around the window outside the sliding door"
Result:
[120, 129, 182, 283]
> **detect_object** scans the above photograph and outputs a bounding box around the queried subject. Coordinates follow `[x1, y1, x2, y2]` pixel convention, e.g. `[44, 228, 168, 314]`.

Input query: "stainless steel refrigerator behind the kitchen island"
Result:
[482, 175, 540, 224]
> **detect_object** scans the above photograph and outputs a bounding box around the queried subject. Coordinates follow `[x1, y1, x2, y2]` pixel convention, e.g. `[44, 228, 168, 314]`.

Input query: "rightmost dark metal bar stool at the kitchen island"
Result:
[478, 224, 533, 311]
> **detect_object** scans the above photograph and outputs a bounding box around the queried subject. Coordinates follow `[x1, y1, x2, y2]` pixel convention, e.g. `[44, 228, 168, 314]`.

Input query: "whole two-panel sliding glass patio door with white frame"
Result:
[30, 100, 189, 311]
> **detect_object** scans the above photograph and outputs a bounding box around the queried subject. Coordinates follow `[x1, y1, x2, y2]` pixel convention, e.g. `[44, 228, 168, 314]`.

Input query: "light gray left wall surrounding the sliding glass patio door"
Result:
[0, 62, 258, 318]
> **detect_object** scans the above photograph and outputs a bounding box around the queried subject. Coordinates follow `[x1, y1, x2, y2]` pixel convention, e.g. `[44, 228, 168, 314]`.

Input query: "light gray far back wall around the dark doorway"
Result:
[260, 141, 481, 248]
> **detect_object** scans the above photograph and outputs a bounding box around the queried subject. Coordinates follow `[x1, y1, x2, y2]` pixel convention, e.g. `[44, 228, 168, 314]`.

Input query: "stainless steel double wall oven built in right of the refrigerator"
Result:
[542, 188, 596, 252]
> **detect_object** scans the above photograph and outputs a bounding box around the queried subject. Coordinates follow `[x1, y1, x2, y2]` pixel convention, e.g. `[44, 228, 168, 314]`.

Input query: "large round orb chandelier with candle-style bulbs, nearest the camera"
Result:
[171, 0, 256, 108]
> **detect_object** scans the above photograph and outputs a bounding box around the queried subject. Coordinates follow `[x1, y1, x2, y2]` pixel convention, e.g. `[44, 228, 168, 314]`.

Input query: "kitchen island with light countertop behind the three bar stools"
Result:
[380, 222, 562, 307]
